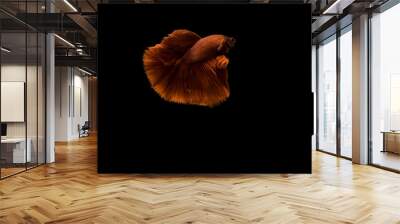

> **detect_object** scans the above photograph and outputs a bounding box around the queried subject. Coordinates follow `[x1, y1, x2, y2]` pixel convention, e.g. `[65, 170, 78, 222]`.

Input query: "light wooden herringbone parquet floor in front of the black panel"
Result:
[0, 137, 400, 224]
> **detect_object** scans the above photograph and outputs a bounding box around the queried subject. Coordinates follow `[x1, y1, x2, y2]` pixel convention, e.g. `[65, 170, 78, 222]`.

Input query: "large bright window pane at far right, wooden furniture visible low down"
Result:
[371, 5, 400, 170]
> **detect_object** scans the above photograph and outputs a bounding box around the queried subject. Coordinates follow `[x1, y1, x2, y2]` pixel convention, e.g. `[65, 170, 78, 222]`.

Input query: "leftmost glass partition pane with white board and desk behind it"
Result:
[0, 32, 27, 177]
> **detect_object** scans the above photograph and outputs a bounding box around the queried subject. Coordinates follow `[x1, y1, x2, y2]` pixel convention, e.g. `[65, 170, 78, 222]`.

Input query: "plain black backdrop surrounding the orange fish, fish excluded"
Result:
[98, 4, 313, 173]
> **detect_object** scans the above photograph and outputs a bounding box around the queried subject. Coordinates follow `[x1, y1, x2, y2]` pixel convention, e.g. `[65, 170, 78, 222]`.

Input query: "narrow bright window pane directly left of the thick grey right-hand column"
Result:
[340, 30, 353, 158]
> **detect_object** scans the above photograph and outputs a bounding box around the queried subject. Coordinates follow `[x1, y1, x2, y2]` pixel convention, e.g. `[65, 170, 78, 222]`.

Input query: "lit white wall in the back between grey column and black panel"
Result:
[55, 67, 89, 141]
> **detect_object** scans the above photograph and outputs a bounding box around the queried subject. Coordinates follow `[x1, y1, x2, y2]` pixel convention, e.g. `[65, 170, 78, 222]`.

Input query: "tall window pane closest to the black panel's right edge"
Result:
[318, 38, 336, 153]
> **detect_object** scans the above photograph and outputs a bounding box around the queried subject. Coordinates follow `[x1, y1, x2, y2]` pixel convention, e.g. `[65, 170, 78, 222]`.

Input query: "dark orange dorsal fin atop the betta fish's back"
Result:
[161, 29, 201, 55]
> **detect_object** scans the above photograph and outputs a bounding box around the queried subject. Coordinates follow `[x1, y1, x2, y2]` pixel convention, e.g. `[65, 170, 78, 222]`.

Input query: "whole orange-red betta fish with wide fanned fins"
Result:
[143, 29, 236, 107]
